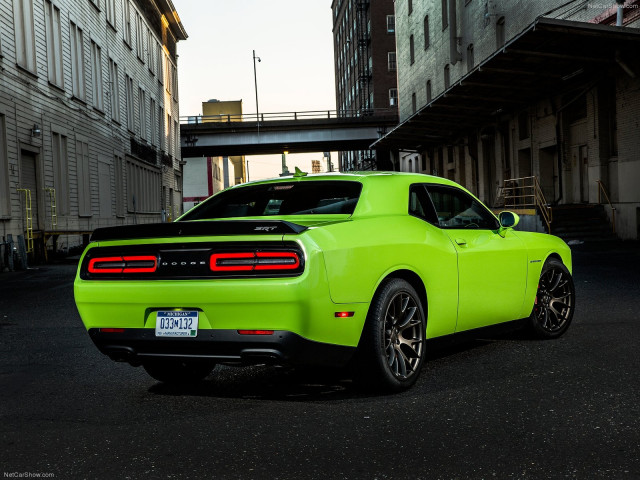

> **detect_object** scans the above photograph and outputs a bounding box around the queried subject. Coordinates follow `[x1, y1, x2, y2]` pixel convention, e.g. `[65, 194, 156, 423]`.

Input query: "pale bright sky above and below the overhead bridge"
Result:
[173, 0, 337, 180]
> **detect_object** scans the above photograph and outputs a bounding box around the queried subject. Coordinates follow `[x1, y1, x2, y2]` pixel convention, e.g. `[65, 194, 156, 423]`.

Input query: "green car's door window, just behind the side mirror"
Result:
[427, 185, 499, 230]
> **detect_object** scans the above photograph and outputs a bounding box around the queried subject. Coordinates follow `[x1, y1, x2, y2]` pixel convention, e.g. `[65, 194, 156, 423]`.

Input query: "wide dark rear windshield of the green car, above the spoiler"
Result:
[181, 181, 362, 220]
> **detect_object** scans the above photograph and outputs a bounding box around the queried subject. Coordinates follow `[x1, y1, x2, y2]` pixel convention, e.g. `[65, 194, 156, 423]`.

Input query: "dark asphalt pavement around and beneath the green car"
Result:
[0, 242, 640, 480]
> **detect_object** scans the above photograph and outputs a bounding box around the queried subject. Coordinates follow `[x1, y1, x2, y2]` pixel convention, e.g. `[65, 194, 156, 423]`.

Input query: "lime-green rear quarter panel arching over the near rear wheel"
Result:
[304, 214, 458, 337]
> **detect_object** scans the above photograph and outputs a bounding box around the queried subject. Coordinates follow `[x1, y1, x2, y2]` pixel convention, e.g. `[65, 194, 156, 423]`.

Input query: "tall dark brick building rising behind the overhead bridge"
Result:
[331, 0, 398, 170]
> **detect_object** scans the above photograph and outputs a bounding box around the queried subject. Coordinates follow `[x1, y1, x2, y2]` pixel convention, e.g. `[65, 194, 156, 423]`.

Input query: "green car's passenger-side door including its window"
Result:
[427, 184, 528, 332]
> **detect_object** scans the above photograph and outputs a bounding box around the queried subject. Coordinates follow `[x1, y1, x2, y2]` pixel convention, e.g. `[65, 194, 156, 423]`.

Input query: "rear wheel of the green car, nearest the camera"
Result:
[354, 278, 426, 391]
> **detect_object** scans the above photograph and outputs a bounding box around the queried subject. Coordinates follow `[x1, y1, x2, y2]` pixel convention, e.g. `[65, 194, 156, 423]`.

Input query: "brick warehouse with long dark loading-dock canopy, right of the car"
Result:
[375, 0, 640, 239]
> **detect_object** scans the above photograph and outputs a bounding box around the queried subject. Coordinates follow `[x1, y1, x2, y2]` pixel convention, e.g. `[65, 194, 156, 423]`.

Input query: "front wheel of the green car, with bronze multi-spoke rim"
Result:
[529, 258, 576, 339]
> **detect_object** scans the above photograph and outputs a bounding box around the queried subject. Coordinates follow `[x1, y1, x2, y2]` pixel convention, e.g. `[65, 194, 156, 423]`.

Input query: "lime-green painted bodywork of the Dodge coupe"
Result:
[74, 173, 571, 352]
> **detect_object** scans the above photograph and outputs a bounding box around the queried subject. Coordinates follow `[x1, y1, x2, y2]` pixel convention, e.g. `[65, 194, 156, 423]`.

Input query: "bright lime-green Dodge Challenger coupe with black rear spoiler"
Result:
[74, 171, 575, 390]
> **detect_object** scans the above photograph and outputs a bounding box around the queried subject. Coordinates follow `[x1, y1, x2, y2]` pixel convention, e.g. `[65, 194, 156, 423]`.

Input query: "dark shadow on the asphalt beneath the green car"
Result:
[149, 339, 497, 401]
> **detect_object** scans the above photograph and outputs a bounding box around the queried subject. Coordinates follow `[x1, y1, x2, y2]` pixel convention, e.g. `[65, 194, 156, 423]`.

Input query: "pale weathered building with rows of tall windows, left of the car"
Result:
[0, 0, 187, 261]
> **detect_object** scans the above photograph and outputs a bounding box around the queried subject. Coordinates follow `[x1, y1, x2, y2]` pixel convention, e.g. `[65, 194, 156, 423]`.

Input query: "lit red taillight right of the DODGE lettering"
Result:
[209, 252, 300, 272]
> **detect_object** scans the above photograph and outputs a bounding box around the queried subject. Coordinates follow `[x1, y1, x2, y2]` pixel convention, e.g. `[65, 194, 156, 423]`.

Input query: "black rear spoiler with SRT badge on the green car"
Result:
[91, 220, 307, 242]
